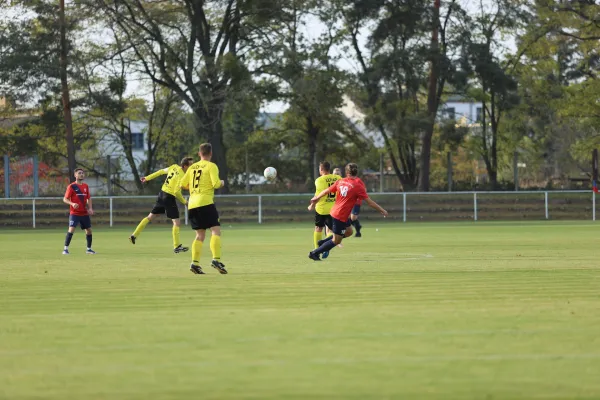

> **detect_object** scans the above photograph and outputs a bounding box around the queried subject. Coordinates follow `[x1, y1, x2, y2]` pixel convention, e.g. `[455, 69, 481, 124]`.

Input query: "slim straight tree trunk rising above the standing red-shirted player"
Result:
[59, 0, 76, 182]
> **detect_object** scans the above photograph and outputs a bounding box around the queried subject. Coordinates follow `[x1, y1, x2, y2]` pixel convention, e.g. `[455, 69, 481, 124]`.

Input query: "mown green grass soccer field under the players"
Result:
[0, 222, 600, 399]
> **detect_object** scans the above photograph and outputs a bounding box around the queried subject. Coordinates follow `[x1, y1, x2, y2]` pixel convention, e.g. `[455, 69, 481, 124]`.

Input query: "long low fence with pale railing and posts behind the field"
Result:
[0, 191, 596, 228]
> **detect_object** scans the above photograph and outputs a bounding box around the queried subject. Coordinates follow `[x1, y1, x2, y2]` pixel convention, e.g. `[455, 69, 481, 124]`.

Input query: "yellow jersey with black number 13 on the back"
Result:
[180, 160, 221, 209]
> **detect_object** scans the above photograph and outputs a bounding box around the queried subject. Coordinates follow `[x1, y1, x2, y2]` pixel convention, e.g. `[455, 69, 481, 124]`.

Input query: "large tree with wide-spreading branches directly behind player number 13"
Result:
[88, 0, 286, 189]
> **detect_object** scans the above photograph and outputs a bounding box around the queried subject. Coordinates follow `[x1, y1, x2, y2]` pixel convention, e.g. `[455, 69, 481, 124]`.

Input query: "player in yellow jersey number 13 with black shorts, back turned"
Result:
[180, 143, 227, 275]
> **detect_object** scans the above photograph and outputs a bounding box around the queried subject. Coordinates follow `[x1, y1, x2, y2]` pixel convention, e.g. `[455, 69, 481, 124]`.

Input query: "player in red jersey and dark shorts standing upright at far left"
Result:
[63, 168, 96, 255]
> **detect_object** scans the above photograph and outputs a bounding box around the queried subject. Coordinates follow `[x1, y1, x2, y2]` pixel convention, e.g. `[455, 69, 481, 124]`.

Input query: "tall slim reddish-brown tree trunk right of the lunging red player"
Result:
[418, 0, 440, 192]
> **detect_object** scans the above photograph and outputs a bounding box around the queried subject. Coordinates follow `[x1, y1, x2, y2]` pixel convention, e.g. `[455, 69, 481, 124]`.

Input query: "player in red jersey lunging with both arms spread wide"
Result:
[308, 163, 388, 261]
